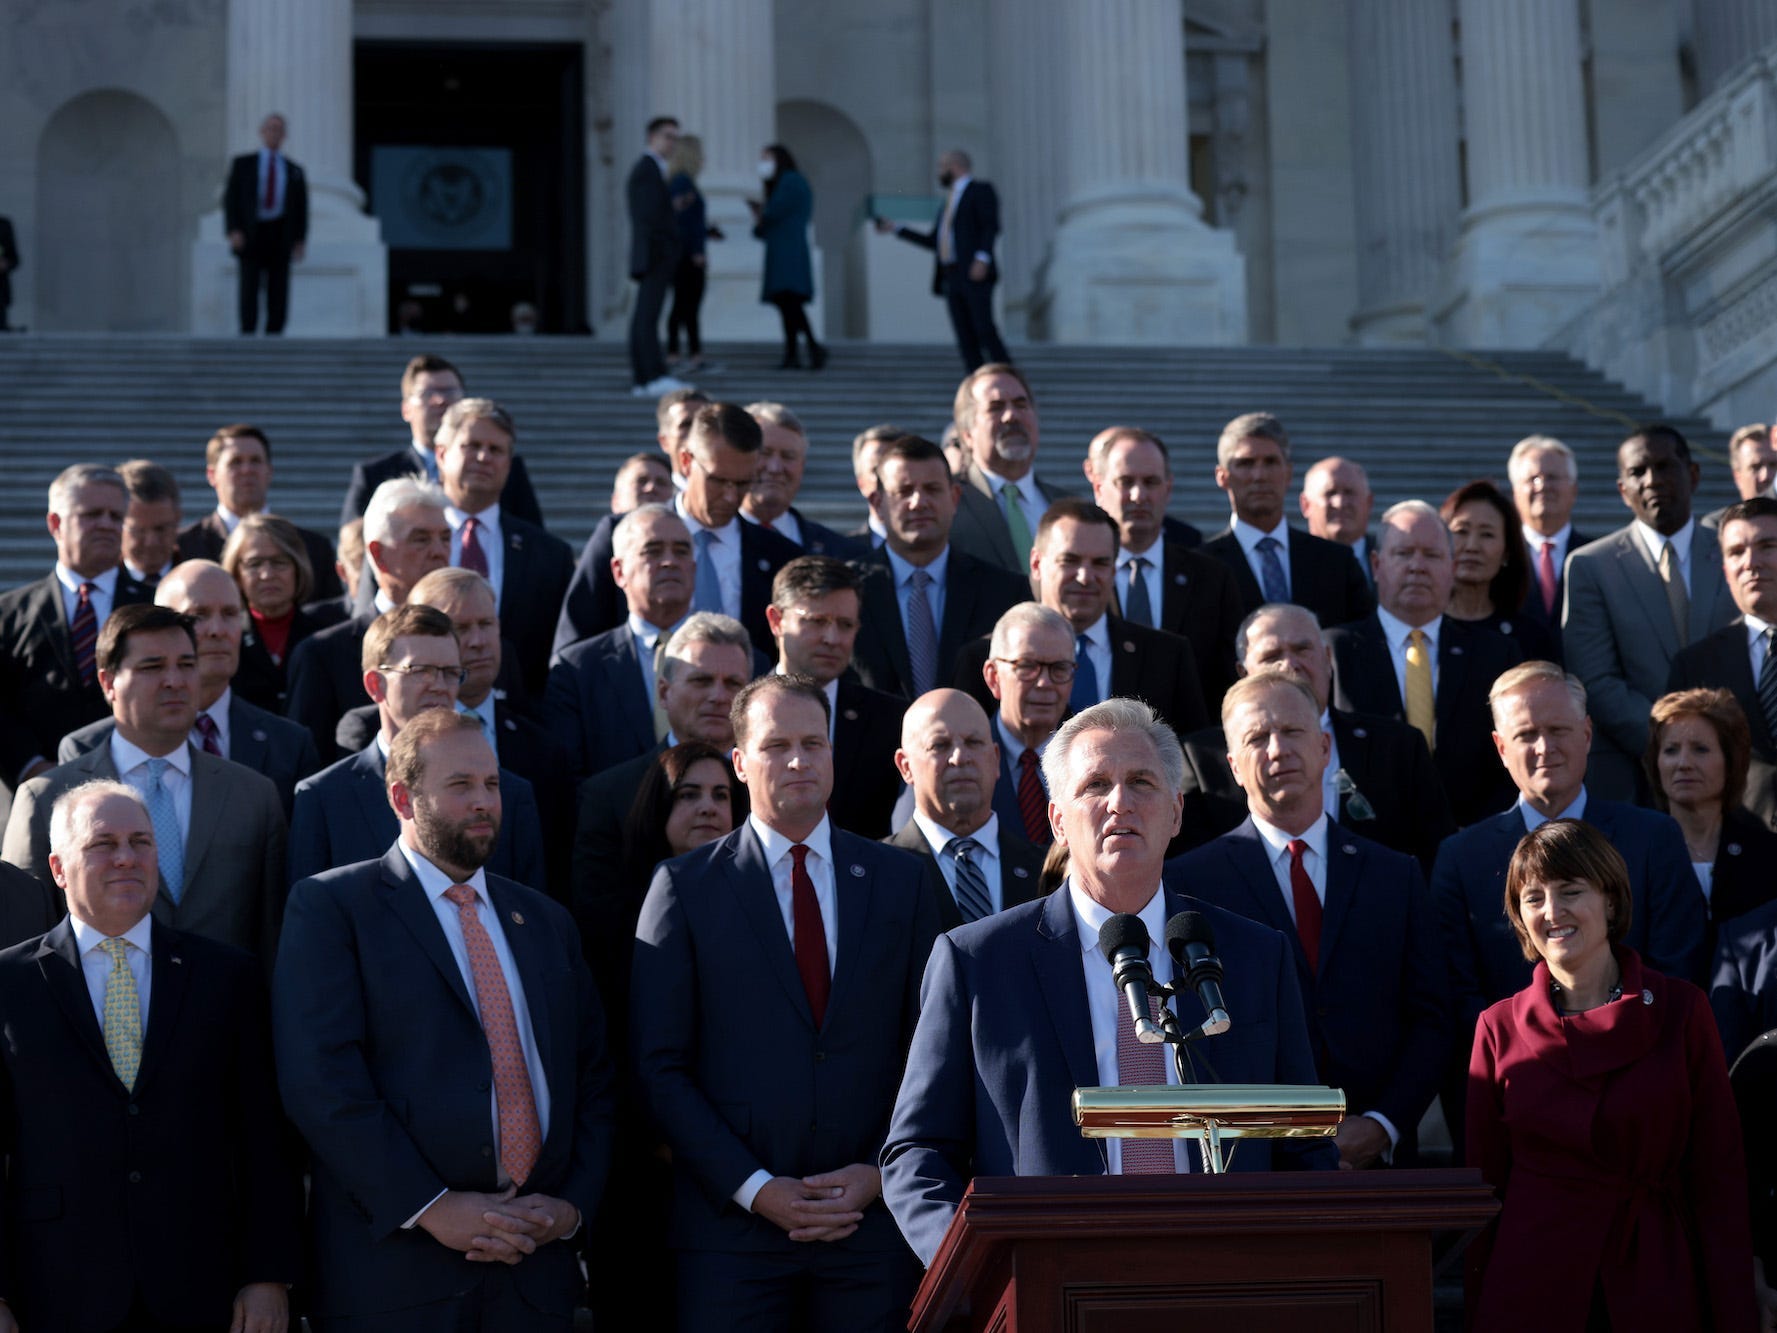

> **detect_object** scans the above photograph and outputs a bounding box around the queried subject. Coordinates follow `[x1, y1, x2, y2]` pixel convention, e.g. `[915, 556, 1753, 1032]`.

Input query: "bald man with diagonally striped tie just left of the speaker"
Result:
[883, 690, 1043, 930]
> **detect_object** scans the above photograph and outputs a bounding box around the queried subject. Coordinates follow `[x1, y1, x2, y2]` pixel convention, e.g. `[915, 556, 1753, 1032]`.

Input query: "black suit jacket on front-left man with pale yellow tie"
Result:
[0, 919, 302, 1333]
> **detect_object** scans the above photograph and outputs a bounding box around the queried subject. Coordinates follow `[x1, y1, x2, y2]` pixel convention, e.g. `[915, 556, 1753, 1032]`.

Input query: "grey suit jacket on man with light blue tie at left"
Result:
[0, 745, 286, 967]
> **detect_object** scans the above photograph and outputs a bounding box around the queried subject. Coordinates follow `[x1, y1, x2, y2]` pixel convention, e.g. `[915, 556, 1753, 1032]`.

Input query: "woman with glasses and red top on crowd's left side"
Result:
[220, 514, 327, 714]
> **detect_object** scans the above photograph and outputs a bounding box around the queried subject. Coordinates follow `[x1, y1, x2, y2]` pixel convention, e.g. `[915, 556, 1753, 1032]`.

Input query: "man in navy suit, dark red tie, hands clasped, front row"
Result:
[631, 675, 942, 1333]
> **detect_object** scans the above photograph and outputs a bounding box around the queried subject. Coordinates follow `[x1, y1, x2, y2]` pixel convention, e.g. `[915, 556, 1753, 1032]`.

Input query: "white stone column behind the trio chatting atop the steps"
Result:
[650, 0, 781, 339]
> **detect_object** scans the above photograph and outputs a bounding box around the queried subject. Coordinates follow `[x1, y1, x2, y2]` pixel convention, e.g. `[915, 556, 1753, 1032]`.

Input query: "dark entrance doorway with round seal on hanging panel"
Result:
[354, 41, 586, 334]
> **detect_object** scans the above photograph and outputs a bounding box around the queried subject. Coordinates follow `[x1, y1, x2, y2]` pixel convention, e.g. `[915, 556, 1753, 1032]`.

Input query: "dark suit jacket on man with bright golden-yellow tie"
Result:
[1327, 613, 1519, 825]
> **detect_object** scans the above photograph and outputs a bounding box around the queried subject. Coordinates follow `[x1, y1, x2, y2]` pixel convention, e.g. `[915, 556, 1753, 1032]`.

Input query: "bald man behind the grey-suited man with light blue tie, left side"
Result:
[55, 560, 322, 819]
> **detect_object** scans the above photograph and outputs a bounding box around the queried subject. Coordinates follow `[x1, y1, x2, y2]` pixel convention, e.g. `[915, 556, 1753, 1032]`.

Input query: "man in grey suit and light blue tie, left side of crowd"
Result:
[4, 604, 284, 963]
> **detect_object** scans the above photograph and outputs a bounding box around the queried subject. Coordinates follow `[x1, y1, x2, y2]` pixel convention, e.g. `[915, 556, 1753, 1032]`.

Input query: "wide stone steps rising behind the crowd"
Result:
[0, 336, 1733, 588]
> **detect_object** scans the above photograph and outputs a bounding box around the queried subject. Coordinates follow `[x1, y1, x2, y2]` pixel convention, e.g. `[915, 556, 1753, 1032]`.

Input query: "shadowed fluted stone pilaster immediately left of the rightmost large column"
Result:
[1351, 0, 1462, 347]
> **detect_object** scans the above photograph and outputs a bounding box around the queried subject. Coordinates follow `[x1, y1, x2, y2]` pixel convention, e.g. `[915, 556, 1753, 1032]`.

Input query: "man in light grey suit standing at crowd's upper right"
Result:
[1562, 425, 1738, 802]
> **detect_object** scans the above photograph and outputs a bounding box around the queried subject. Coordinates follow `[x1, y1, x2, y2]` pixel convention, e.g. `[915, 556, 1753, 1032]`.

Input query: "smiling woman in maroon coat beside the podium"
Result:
[1468, 819, 1757, 1333]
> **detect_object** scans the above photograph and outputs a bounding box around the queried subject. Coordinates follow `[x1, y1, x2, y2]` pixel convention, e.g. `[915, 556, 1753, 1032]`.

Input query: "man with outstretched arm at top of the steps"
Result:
[876, 148, 1011, 370]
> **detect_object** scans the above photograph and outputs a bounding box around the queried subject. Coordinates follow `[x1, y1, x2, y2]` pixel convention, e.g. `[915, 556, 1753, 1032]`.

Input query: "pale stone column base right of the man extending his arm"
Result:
[1031, 197, 1247, 347]
